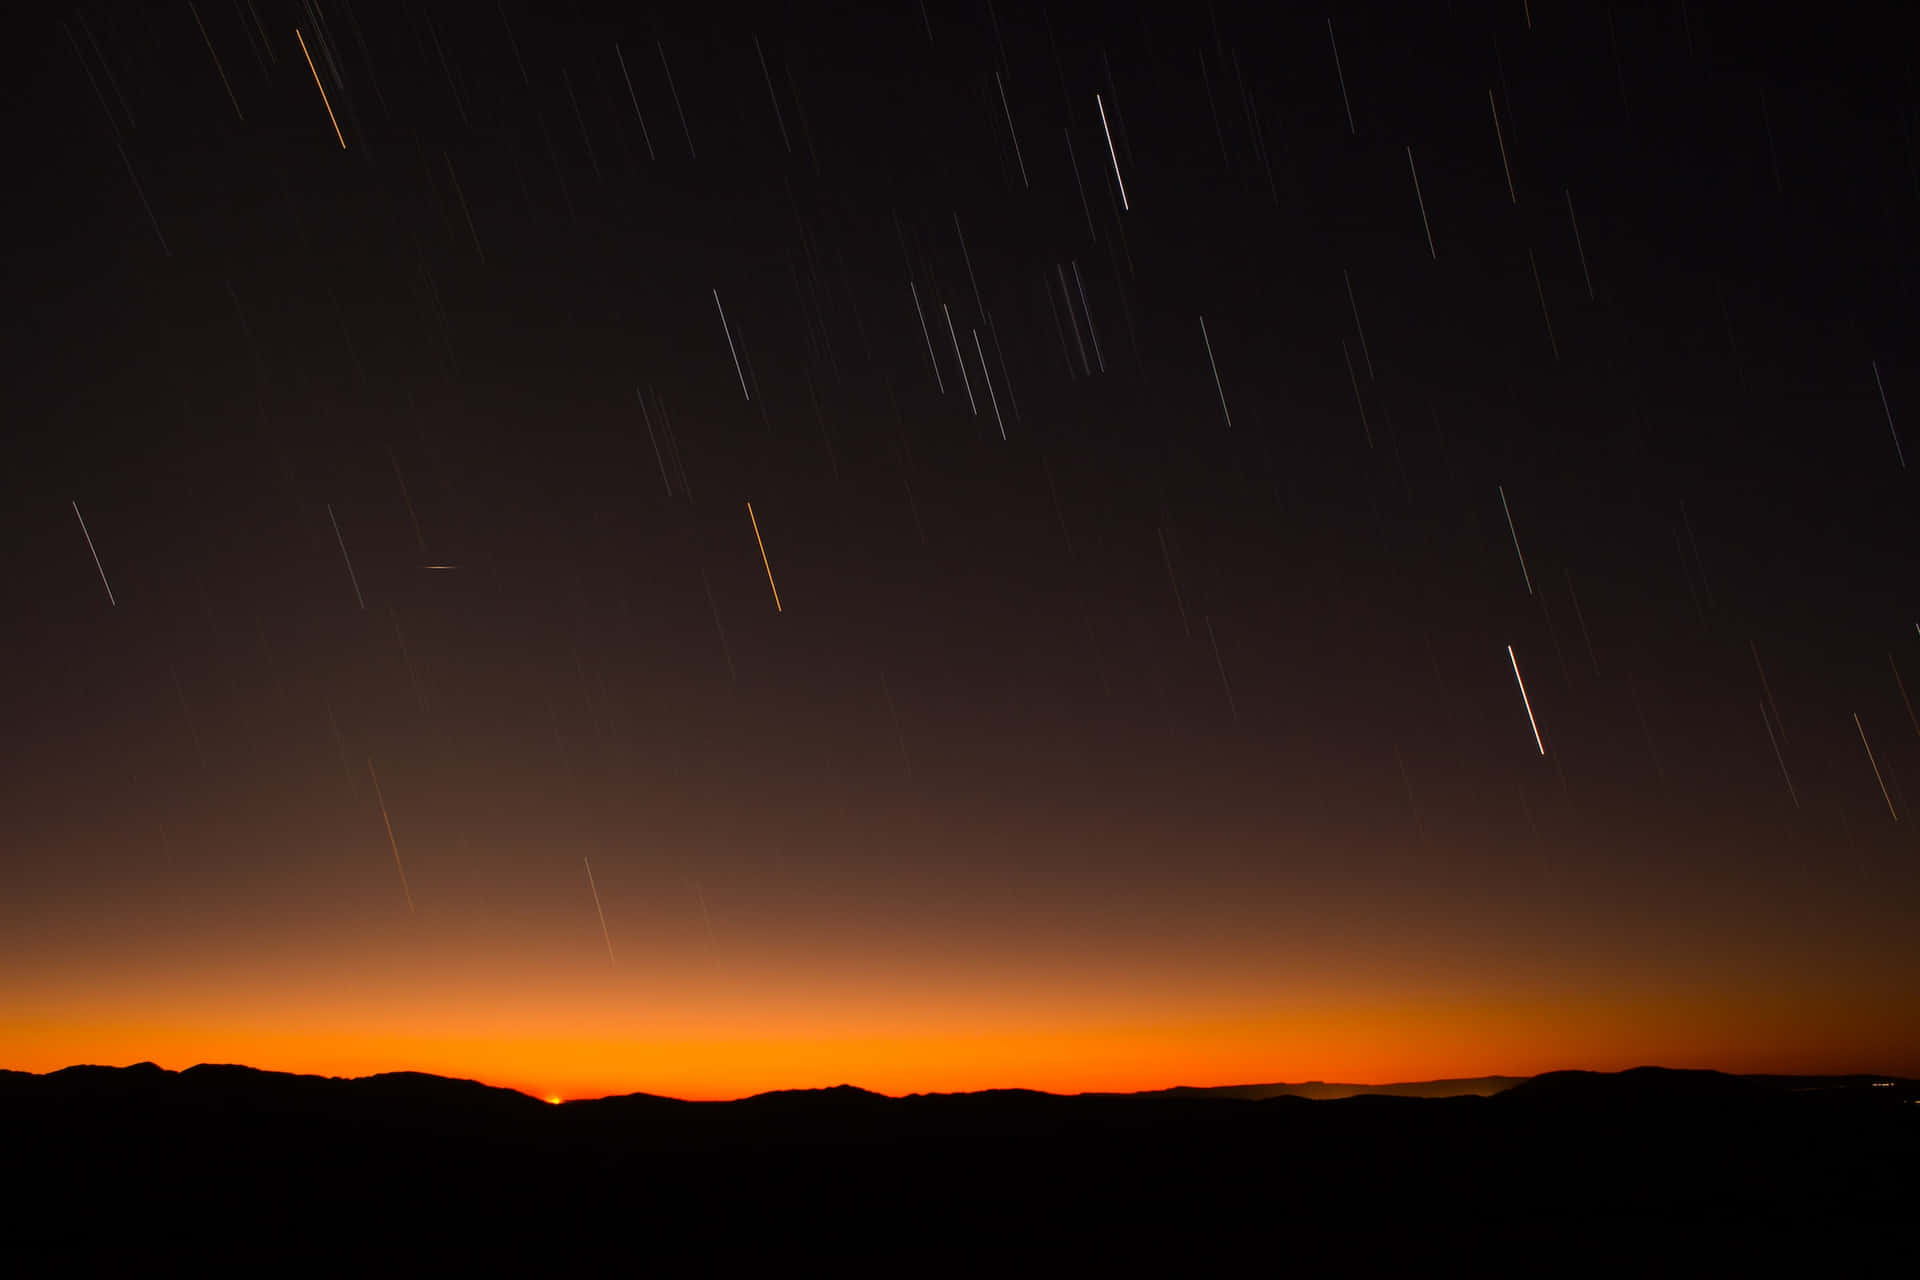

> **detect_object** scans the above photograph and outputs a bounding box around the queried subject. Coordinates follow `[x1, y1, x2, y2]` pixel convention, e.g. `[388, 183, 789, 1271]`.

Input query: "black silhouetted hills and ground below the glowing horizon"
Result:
[0, 1065, 1920, 1274]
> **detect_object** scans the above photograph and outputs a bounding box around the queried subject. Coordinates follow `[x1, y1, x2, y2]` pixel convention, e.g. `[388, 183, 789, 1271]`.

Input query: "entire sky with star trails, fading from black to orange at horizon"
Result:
[0, 0, 1920, 1098]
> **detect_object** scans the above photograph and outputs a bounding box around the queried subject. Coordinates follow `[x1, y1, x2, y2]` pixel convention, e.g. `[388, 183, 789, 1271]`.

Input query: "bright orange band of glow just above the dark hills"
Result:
[0, 996, 1920, 1102]
